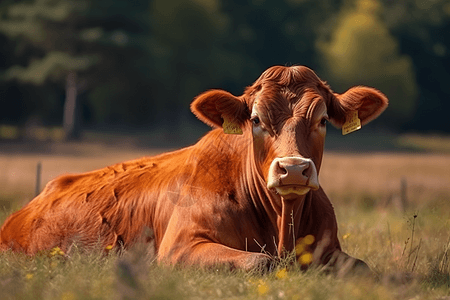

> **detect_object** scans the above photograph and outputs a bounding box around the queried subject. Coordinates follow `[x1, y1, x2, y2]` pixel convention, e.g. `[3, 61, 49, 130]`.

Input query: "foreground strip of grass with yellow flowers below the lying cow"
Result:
[0, 238, 449, 299]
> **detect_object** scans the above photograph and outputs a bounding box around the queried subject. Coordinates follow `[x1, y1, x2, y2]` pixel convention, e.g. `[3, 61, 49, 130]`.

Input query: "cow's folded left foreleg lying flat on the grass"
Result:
[158, 241, 273, 272]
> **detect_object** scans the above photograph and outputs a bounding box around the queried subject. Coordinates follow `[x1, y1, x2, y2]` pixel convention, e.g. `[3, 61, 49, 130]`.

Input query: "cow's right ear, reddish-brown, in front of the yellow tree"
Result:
[328, 86, 388, 128]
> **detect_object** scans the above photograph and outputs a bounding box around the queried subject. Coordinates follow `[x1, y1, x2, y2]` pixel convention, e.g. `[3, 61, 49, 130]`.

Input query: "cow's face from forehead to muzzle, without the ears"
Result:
[250, 83, 329, 198]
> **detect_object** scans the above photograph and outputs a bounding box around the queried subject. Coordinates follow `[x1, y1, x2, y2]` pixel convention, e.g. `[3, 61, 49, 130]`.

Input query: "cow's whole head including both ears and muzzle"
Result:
[191, 66, 388, 199]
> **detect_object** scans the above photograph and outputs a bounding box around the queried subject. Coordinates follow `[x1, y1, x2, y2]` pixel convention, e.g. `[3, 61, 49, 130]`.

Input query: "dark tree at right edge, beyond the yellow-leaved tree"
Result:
[383, 0, 450, 132]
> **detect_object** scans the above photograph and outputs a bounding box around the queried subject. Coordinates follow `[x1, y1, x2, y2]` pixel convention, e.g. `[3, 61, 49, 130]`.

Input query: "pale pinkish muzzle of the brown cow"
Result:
[267, 156, 319, 196]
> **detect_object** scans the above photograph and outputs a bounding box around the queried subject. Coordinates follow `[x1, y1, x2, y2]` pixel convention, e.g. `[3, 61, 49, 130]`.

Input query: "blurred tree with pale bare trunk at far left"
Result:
[0, 0, 94, 139]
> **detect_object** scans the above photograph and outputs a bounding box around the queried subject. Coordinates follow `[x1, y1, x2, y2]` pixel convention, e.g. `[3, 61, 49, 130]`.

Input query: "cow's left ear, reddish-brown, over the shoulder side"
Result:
[191, 90, 250, 128]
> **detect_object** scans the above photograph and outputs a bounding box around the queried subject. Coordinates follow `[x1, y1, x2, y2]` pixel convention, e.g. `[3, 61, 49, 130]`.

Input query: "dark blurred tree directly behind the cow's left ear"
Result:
[150, 0, 246, 137]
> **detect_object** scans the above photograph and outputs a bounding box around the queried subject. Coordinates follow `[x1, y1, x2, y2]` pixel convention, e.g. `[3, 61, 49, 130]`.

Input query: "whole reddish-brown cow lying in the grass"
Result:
[0, 66, 388, 270]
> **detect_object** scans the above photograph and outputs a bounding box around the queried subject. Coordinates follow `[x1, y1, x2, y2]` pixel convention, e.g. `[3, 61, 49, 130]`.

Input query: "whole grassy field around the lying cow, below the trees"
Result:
[0, 139, 450, 300]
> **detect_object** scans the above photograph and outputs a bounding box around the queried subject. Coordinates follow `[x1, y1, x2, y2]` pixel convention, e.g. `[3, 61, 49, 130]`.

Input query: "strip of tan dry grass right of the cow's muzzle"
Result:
[320, 153, 450, 205]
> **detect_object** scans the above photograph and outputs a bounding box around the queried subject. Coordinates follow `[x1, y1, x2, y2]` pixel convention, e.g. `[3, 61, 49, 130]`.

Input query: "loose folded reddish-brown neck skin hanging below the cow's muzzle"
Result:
[244, 149, 312, 257]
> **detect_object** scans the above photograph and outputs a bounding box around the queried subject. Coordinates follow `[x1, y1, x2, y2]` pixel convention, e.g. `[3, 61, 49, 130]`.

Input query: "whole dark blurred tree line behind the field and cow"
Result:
[0, 0, 450, 137]
